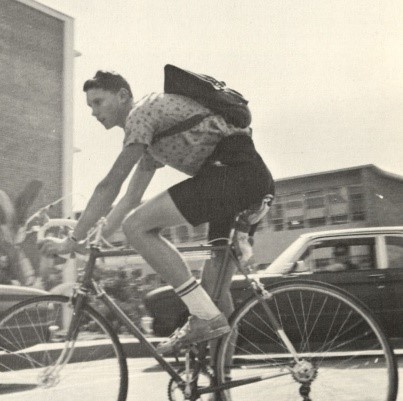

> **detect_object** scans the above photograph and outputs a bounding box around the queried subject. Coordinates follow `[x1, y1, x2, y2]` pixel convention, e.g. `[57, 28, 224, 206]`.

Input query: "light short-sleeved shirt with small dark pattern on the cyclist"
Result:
[124, 93, 251, 176]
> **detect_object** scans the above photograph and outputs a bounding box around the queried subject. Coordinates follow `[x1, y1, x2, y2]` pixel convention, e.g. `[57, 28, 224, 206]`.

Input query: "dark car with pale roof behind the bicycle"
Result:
[145, 227, 403, 338]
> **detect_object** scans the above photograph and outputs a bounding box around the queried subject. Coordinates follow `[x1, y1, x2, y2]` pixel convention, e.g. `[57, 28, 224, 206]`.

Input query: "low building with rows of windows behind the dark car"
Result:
[255, 165, 403, 263]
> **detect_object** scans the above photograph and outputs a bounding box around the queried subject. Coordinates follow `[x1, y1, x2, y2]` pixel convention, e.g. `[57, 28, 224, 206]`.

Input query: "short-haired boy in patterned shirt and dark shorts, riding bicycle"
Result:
[41, 71, 274, 353]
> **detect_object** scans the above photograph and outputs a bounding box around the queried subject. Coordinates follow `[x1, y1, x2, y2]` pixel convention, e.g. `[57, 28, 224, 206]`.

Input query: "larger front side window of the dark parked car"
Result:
[295, 238, 376, 272]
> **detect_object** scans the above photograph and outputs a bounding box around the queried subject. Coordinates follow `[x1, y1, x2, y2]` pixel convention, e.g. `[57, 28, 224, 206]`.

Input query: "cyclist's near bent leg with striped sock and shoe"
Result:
[123, 191, 229, 353]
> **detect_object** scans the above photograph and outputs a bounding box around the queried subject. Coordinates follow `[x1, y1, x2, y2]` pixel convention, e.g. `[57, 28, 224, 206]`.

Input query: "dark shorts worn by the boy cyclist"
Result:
[168, 135, 274, 240]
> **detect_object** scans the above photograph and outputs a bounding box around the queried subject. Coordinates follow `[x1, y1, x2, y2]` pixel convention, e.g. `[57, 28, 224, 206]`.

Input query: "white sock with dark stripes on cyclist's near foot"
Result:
[175, 277, 220, 320]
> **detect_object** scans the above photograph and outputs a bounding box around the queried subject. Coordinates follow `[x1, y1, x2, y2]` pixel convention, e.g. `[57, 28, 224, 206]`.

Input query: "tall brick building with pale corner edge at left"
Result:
[0, 0, 74, 216]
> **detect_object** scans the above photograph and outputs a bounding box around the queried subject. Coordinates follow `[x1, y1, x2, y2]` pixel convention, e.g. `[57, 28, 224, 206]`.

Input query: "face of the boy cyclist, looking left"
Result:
[87, 88, 123, 129]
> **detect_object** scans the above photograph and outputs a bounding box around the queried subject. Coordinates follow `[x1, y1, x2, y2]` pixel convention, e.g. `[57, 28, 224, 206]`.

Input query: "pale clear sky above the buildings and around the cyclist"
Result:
[38, 0, 403, 210]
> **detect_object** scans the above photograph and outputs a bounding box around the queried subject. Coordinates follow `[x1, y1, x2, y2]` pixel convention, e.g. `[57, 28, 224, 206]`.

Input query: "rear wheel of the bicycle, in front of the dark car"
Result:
[216, 280, 397, 401]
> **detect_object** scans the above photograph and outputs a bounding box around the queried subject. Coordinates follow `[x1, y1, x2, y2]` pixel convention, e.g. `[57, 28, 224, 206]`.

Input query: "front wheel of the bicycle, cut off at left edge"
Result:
[0, 295, 128, 401]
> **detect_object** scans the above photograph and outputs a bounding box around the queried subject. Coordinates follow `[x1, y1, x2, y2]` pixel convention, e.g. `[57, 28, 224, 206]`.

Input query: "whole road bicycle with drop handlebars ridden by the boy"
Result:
[0, 205, 398, 401]
